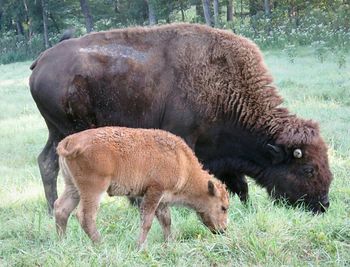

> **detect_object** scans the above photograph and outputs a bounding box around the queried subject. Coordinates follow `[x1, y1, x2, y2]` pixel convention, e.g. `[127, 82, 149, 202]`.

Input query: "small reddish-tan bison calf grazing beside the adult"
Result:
[54, 127, 229, 246]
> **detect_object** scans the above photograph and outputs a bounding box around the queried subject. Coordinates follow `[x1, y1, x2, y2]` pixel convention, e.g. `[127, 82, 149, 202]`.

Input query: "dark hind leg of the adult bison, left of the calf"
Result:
[38, 133, 59, 215]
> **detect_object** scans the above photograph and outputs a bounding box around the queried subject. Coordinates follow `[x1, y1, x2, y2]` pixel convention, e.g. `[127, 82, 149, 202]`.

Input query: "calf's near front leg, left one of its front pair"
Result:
[137, 186, 163, 249]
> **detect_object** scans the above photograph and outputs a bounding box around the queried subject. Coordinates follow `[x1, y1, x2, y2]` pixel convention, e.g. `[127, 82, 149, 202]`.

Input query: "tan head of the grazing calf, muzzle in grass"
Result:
[197, 180, 229, 233]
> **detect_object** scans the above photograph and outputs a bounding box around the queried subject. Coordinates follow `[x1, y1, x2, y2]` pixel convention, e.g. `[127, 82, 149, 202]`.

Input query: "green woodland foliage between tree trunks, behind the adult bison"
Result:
[0, 0, 350, 67]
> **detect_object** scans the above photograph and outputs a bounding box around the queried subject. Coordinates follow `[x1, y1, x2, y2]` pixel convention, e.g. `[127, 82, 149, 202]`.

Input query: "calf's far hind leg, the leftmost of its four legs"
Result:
[54, 182, 80, 236]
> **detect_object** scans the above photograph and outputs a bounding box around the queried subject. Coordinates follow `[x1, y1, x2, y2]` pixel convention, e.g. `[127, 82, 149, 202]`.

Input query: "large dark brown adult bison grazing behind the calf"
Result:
[30, 24, 332, 216]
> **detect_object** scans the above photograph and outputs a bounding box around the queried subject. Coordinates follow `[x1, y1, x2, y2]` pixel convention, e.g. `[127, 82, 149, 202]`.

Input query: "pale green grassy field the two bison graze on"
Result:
[0, 49, 350, 266]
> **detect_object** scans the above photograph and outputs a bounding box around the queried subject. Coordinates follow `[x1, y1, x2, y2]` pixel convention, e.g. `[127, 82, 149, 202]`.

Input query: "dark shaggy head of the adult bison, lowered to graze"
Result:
[264, 121, 332, 213]
